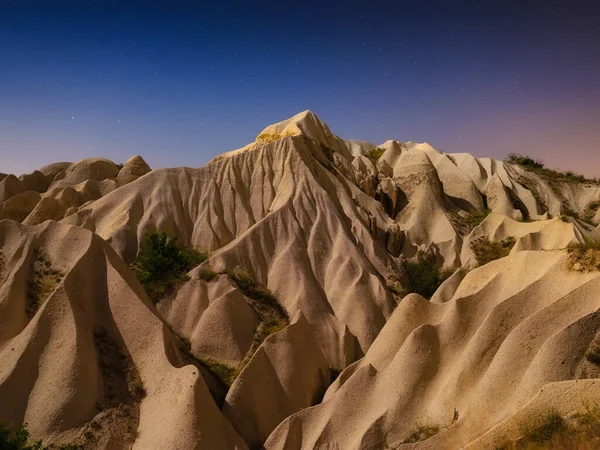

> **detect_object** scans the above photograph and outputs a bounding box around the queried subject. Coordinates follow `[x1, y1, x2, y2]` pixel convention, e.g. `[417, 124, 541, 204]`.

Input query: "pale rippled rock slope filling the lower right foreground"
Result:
[265, 250, 600, 450]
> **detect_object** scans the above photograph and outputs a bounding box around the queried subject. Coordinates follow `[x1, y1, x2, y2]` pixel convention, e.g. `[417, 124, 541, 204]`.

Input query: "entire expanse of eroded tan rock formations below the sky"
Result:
[0, 111, 600, 450]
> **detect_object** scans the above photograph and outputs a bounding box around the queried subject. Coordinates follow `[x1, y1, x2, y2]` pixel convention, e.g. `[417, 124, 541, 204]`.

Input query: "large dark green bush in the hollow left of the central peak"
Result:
[131, 231, 208, 303]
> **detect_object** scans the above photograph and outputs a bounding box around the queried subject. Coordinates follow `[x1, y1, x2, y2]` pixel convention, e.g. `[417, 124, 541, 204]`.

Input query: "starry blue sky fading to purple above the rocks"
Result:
[0, 0, 600, 175]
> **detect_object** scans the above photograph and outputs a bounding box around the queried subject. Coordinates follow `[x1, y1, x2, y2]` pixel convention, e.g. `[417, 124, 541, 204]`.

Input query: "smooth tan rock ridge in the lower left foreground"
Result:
[0, 221, 247, 450]
